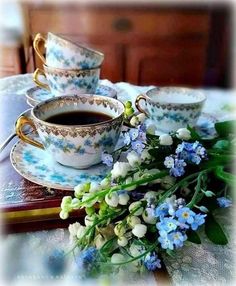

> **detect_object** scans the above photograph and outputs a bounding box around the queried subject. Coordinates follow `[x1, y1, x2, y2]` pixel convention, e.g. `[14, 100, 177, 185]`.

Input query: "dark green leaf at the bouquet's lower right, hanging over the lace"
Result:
[205, 213, 228, 245]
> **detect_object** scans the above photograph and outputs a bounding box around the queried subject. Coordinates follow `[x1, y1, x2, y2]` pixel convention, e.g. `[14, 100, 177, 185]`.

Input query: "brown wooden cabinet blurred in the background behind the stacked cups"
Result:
[24, 3, 231, 86]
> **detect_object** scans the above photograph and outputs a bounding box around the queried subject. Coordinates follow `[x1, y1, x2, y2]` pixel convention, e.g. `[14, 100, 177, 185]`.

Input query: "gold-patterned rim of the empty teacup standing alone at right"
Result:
[147, 86, 206, 108]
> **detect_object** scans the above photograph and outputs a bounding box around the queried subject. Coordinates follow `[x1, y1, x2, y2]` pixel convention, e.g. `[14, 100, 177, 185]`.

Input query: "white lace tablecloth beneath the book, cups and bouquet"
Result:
[0, 74, 236, 286]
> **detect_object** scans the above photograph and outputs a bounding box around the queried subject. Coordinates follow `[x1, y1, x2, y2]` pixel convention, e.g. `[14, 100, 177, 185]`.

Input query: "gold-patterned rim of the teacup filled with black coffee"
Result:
[31, 94, 125, 129]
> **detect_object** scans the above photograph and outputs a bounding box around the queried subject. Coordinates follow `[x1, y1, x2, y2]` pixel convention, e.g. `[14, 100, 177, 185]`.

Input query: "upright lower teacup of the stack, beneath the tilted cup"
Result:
[33, 65, 100, 96]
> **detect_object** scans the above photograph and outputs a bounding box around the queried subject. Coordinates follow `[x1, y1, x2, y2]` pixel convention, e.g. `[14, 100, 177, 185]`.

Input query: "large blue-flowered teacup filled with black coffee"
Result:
[16, 94, 124, 169]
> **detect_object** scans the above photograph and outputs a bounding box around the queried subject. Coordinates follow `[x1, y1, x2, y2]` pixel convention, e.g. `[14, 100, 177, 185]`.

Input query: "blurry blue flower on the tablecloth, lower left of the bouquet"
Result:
[46, 249, 65, 275]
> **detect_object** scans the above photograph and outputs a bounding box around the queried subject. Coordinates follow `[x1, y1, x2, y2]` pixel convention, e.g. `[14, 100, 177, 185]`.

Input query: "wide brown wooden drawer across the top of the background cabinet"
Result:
[29, 7, 209, 41]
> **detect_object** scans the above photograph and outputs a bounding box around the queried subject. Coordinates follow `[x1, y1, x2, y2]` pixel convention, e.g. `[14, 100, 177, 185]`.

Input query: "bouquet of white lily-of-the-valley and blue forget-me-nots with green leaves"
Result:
[60, 102, 236, 275]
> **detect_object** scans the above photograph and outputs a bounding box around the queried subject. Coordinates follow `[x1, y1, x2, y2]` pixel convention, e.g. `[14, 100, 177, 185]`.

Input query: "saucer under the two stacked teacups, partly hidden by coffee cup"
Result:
[26, 84, 117, 107]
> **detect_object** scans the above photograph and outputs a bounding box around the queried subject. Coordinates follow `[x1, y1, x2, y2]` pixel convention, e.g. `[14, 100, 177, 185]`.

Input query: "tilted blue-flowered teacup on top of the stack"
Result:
[33, 32, 104, 69]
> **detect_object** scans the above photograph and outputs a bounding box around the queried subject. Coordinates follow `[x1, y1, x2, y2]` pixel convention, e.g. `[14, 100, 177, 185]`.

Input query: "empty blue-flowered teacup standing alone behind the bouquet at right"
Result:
[135, 87, 206, 133]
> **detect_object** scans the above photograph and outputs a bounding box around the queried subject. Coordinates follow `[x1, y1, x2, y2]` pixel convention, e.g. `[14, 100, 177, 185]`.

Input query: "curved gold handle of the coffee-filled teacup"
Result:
[16, 116, 44, 149]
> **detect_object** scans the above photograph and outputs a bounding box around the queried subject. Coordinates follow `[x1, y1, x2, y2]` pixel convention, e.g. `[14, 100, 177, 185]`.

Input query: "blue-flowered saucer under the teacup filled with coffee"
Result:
[10, 135, 110, 191]
